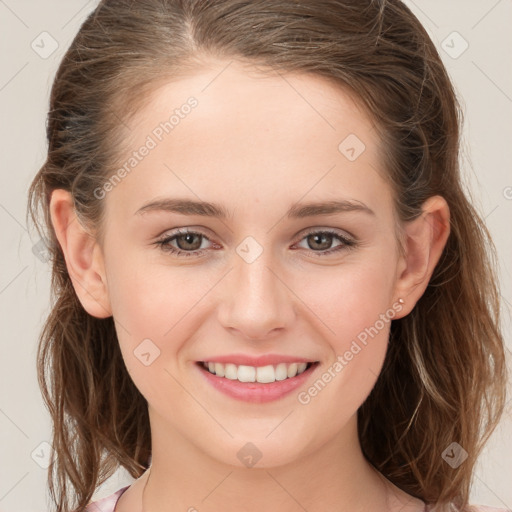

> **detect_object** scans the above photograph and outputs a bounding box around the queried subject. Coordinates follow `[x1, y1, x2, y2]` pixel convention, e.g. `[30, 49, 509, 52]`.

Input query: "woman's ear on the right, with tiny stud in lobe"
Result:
[395, 196, 450, 318]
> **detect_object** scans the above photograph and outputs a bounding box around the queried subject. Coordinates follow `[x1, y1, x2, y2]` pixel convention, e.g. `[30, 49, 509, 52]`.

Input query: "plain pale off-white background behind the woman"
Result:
[0, 0, 512, 512]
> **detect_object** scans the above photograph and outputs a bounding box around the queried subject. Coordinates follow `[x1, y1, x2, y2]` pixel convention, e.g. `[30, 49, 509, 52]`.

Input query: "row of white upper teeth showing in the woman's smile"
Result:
[203, 362, 307, 384]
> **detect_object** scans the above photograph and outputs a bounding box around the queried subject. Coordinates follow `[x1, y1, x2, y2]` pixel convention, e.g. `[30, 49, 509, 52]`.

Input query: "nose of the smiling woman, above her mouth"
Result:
[218, 251, 295, 340]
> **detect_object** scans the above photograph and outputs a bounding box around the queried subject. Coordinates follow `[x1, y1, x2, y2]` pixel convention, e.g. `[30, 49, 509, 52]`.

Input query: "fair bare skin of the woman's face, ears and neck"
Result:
[51, 61, 449, 512]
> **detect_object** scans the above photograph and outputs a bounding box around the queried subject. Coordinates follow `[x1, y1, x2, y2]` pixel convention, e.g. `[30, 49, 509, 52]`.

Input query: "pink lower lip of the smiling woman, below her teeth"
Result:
[196, 362, 318, 403]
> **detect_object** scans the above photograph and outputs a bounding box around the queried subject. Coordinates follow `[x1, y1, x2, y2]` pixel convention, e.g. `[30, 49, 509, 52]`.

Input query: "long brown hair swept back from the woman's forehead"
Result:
[29, 0, 507, 512]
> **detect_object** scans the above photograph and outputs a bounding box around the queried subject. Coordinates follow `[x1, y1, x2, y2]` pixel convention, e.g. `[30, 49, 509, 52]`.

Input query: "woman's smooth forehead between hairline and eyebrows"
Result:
[104, 61, 390, 222]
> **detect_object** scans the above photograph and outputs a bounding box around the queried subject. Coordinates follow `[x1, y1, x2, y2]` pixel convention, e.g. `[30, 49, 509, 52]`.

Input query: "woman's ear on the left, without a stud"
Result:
[50, 189, 112, 318]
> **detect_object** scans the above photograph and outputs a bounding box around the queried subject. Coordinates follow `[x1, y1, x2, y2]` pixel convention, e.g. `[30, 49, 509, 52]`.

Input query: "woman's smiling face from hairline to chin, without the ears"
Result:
[98, 62, 400, 467]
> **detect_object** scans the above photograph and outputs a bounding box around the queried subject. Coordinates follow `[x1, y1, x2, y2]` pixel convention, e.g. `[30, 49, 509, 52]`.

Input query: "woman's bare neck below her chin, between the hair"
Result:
[142, 412, 423, 512]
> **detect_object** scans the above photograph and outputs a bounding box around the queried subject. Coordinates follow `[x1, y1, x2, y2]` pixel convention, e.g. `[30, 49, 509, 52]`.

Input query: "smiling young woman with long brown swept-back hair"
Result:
[29, 0, 506, 512]
